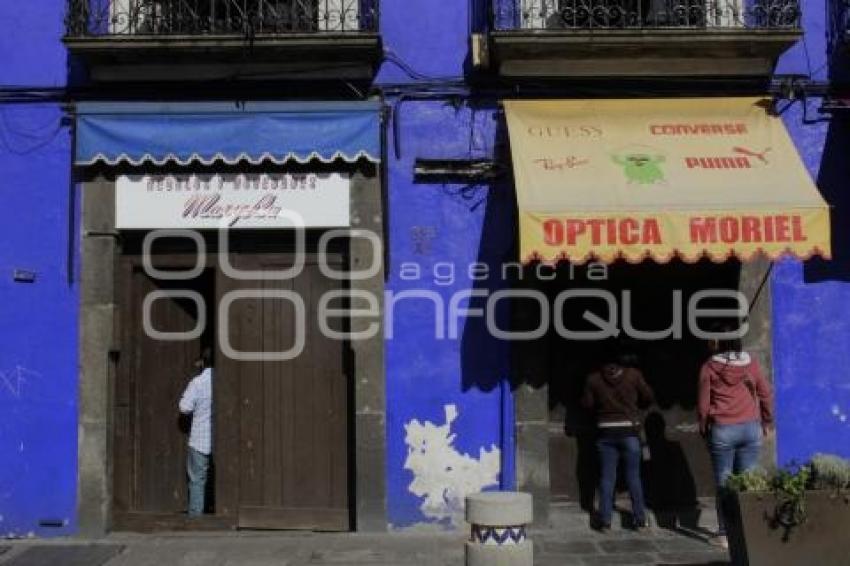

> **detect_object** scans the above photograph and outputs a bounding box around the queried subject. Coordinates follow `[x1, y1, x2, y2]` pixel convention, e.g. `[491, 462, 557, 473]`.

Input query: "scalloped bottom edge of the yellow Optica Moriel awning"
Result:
[523, 247, 832, 265]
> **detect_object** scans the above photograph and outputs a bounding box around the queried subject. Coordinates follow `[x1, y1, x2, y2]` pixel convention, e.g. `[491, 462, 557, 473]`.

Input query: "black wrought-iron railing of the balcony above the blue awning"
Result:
[66, 0, 379, 37]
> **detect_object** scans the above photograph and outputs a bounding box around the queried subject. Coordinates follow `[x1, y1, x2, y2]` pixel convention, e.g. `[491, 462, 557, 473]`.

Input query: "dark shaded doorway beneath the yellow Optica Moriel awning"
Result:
[514, 260, 741, 511]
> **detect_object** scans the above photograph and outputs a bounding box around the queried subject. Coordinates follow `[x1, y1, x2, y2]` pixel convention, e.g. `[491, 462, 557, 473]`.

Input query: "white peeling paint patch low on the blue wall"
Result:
[404, 405, 501, 527]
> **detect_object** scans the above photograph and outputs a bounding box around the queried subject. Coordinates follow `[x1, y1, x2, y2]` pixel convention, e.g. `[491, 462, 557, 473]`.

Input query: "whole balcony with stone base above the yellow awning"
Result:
[488, 0, 802, 78]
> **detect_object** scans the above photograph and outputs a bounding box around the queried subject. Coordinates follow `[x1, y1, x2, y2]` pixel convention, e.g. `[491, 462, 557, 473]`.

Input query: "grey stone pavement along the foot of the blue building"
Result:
[0, 506, 726, 566]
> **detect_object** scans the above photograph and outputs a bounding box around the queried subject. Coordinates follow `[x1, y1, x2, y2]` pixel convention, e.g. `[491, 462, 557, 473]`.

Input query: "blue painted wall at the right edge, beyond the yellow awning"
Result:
[772, 0, 850, 464]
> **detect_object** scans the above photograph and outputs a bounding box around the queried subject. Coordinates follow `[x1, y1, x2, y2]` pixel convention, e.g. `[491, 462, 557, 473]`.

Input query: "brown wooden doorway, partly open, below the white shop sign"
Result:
[113, 233, 354, 531]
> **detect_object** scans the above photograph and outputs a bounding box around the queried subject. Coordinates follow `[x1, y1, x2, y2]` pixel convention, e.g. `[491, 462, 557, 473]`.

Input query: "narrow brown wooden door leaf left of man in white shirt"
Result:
[113, 256, 212, 527]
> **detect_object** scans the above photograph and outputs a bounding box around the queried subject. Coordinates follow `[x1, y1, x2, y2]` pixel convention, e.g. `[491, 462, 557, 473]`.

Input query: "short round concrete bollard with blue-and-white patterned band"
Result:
[466, 491, 534, 566]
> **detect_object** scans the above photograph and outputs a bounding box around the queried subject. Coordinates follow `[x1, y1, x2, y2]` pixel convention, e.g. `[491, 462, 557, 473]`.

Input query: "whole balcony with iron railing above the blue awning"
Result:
[64, 0, 382, 82]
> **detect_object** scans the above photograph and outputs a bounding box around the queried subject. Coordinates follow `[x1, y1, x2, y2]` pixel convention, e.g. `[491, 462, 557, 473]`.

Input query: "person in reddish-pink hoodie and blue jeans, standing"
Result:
[698, 326, 773, 548]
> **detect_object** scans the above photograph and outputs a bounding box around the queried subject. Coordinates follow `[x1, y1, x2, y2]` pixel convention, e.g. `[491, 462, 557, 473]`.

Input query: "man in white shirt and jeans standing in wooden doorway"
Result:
[180, 350, 213, 517]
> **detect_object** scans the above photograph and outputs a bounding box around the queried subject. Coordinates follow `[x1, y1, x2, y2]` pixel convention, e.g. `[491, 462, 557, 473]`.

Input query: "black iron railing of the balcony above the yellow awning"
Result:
[491, 0, 801, 31]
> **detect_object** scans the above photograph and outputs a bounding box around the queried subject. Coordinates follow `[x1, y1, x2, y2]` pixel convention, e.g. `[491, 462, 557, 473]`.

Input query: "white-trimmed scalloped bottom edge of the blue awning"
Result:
[76, 151, 381, 166]
